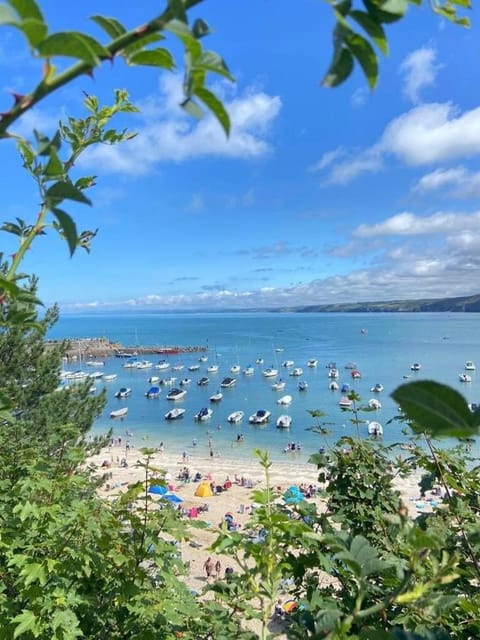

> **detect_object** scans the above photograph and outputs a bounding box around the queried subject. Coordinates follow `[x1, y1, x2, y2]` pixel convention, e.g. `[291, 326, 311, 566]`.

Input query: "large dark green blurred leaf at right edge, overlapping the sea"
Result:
[392, 380, 479, 438]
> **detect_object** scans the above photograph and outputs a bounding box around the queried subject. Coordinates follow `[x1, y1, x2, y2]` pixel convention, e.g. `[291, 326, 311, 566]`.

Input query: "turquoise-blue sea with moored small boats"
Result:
[48, 312, 480, 464]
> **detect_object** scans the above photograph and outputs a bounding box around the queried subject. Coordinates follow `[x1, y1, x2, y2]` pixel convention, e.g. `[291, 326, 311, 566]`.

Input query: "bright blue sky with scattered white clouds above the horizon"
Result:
[0, 0, 480, 313]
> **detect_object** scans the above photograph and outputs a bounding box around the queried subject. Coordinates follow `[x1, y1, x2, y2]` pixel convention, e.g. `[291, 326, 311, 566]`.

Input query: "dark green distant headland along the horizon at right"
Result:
[283, 294, 480, 313]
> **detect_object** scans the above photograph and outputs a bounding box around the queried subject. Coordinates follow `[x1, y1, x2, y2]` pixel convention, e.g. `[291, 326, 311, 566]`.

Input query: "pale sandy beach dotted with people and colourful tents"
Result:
[90, 442, 431, 637]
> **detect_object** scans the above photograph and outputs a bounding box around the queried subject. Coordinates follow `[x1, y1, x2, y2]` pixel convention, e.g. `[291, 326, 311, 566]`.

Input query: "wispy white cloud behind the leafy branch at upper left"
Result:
[83, 76, 282, 174]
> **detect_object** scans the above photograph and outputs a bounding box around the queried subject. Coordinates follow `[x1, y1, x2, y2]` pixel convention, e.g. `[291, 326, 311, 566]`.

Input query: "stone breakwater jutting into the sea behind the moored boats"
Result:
[46, 337, 207, 360]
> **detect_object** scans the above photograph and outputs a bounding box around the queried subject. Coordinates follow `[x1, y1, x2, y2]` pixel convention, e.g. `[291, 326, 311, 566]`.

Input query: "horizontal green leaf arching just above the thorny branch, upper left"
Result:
[37, 31, 110, 66]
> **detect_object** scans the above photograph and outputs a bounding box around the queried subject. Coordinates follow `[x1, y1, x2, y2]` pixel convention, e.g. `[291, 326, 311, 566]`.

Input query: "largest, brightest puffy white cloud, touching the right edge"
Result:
[315, 103, 480, 184]
